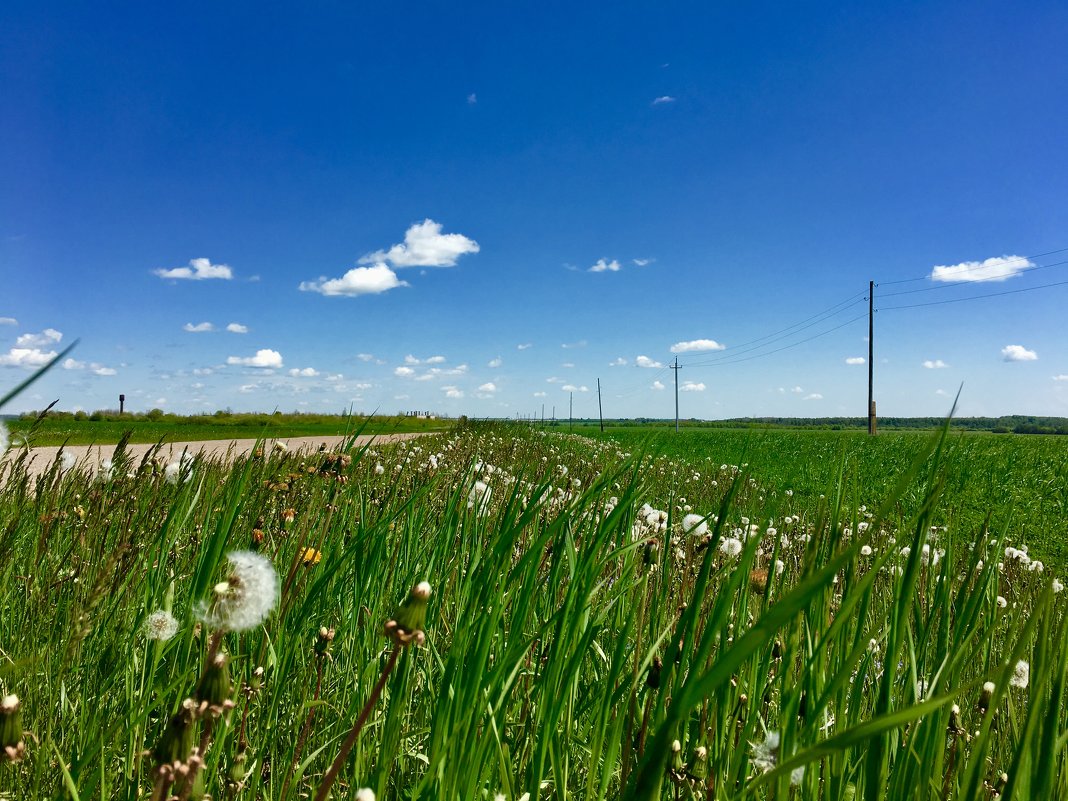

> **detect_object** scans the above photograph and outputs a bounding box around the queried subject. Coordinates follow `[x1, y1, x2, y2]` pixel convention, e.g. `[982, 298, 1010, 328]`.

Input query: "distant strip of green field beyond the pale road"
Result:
[1, 414, 453, 445]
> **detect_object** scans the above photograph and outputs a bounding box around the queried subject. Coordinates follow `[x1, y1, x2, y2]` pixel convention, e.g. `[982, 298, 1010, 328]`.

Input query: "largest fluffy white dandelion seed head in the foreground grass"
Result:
[198, 551, 278, 631]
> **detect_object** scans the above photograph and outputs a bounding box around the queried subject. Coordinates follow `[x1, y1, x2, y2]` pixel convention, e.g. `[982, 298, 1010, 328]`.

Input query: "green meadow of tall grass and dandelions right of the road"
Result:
[0, 424, 1068, 801]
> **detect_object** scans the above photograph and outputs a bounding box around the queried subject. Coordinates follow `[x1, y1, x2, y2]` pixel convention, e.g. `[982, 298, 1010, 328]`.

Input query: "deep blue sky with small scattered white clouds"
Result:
[0, 2, 1068, 418]
